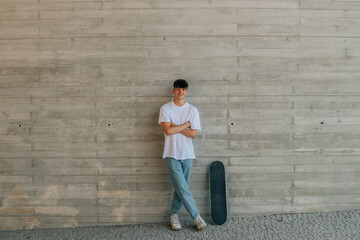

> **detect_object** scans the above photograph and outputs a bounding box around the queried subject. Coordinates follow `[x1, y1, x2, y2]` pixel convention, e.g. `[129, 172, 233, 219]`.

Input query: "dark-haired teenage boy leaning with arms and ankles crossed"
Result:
[159, 79, 207, 230]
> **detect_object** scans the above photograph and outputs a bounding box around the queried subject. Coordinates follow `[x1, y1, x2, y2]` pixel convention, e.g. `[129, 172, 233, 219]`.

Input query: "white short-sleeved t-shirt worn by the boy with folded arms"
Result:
[159, 101, 201, 160]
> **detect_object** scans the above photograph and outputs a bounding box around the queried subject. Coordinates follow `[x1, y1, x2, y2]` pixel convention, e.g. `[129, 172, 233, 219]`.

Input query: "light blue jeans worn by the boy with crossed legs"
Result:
[165, 157, 200, 218]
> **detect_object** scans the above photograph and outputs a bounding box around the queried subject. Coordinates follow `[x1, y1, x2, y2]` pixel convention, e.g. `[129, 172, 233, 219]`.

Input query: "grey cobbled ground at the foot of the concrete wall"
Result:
[0, 210, 360, 240]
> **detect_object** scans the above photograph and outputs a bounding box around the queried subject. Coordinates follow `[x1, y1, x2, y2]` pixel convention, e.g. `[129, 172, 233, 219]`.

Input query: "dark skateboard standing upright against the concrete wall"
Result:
[209, 161, 227, 225]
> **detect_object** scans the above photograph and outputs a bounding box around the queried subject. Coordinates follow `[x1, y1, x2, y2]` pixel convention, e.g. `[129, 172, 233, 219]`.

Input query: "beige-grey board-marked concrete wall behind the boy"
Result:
[0, 0, 360, 230]
